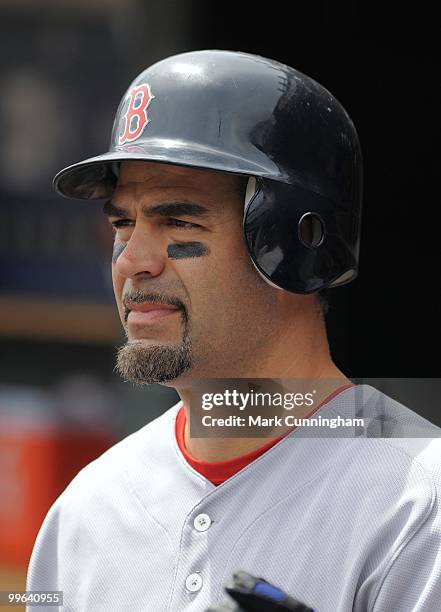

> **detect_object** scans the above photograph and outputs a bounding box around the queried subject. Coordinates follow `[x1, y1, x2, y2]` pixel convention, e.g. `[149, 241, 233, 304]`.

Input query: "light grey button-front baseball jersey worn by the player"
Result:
[27, 385, 441, 612]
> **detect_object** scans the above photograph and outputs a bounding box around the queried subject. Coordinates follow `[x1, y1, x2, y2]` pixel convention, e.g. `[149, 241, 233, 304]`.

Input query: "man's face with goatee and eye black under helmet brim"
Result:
[105, 162, 279, 386]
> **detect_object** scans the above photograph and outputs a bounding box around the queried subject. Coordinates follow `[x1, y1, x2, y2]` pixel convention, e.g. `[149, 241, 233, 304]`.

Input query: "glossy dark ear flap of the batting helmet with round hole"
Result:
[243, 179, 358, 294]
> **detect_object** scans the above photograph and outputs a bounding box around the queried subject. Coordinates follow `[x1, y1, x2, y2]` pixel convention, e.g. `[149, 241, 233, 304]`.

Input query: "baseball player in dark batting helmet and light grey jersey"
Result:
[28, 51, 441, 612]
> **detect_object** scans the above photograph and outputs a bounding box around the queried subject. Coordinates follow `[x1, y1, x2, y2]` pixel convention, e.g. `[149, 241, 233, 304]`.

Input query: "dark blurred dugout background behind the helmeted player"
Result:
[0, 0, 441, 590]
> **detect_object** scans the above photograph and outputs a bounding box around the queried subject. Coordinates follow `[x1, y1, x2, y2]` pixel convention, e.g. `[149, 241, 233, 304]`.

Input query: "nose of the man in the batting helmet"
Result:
[112, 225, 167, 278]
